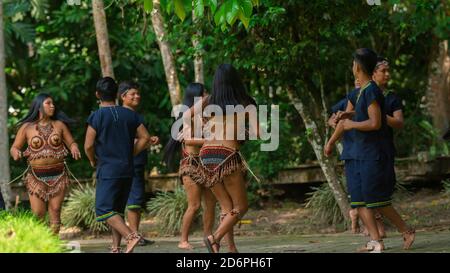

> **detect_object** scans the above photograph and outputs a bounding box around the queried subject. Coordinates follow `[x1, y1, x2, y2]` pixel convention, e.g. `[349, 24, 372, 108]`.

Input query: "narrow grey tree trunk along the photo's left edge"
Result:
[0, 0, 12, 209]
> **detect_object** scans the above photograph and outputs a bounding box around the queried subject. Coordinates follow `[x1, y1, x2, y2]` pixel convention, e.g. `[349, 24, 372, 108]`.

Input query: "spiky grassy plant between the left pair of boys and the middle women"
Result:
[147, 186, 195, 235]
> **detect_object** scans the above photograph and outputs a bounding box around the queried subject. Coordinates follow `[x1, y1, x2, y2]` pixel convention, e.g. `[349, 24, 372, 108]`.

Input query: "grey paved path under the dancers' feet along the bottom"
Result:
[76, 230, 450, 253]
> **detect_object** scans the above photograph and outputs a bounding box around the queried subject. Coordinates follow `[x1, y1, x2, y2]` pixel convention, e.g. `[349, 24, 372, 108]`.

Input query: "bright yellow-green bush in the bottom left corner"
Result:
[0, 211, 63, 253]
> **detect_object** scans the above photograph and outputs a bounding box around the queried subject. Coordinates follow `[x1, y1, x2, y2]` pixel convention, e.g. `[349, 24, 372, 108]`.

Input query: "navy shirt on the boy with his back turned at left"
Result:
[87, 106, 143, 178]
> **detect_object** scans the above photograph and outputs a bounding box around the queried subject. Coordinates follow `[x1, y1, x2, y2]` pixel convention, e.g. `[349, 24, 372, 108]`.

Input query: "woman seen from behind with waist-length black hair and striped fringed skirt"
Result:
[183, 64, 259, 253]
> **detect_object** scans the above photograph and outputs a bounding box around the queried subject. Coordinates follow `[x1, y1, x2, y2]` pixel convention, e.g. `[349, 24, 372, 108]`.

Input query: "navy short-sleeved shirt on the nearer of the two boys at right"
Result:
[349, 81, 387, 160]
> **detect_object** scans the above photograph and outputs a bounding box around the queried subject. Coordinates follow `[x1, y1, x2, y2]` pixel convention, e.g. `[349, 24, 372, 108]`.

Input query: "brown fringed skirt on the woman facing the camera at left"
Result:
[24, 162, 69, 201]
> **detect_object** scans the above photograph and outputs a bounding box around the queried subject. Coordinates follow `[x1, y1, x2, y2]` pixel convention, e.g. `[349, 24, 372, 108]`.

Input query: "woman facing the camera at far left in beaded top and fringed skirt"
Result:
[10, 93, 81, 234]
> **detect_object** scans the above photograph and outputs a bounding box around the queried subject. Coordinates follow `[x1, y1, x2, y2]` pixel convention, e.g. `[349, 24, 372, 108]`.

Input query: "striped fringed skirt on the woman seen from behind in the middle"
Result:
[200, 146, 247, 188]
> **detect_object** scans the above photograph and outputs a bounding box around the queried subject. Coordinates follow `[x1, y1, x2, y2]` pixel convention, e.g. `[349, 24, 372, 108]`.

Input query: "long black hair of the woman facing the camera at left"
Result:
[16, 93, 75, 128]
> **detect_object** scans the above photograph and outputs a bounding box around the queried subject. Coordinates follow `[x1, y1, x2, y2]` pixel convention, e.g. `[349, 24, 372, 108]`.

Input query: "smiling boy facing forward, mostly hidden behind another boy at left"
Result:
[119, 81, 159, 246]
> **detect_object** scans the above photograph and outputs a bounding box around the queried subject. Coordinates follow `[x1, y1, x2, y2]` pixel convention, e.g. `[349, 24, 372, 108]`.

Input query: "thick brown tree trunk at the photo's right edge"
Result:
[427, 41, 450, 135]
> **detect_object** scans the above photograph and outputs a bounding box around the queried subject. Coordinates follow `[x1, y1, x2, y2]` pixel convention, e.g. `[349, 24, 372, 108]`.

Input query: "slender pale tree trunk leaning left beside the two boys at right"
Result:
[288, 89, 350, 221]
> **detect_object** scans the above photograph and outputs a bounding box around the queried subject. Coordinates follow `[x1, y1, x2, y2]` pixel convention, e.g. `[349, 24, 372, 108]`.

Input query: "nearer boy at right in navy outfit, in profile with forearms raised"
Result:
[325, 48, 392, 252]
